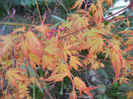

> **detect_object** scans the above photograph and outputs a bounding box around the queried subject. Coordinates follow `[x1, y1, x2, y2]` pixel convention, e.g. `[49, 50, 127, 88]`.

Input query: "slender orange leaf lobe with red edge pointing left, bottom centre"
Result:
[45, 73, 68, 82]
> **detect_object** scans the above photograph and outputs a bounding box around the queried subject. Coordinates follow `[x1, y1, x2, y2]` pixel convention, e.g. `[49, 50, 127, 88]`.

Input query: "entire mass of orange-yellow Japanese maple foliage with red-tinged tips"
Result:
[0, 0, 133, 99]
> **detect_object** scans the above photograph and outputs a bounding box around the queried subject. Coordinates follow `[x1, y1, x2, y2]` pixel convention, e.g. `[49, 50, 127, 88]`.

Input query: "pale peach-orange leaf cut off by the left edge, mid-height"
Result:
[0, 35, 13, 56]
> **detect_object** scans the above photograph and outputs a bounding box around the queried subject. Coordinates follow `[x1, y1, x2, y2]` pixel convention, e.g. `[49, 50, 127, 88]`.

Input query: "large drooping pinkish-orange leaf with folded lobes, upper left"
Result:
[18, 31, 42, 58]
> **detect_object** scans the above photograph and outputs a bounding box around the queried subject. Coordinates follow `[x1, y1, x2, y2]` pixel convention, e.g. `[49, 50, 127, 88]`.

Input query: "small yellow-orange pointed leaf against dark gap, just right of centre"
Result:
[69, 56, 83, 70]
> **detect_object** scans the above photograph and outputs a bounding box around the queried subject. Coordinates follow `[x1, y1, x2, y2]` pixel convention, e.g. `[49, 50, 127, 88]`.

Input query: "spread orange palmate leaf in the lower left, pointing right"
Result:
[6, 68, 27, 87]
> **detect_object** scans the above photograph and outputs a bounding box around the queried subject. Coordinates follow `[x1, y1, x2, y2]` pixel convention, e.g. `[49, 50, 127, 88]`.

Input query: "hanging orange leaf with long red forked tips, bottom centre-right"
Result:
[74, 76, 99, 98]
